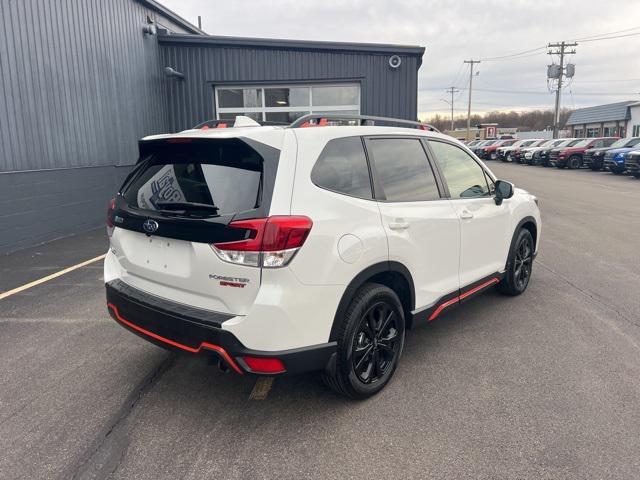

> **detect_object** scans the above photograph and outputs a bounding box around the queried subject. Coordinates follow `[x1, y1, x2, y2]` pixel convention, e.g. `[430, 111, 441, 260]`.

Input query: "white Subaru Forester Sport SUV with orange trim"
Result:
[104, 114, 541, 398]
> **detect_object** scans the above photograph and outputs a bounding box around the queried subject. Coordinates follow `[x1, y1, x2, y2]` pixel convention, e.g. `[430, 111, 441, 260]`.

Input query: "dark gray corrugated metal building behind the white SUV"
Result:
[0, 0, 424, 254]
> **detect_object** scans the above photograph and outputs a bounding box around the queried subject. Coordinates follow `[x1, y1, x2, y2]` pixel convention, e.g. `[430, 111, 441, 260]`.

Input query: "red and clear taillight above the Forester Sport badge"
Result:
[211, 216, 313, 268]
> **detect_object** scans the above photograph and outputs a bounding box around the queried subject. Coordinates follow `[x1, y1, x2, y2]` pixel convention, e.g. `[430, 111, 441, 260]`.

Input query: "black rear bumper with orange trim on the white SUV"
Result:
[106, 280, 336, 375]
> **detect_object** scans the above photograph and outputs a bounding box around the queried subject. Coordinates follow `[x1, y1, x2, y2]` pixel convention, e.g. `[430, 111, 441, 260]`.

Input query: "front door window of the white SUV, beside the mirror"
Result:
[429, 141, 490, 198]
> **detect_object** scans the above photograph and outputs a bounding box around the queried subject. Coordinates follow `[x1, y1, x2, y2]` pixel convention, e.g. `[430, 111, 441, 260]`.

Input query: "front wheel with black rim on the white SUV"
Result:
[498, 228, 534, 296]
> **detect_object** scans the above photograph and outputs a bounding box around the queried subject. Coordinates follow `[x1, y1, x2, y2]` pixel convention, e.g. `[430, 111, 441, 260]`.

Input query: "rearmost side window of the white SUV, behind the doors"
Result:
[311, 137, 373, 198]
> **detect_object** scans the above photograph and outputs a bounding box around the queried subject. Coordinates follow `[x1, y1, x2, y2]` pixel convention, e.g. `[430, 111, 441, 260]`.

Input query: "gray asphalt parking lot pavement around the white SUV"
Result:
[0, 162, 640, 479]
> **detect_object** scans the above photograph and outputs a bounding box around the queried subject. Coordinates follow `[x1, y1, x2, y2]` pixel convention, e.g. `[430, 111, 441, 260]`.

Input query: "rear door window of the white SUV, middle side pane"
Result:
[367, 138, 440, 202]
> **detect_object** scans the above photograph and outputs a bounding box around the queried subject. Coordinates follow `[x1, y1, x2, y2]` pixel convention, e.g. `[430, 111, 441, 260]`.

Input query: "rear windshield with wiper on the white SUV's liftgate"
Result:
[121, 139, 263, 216]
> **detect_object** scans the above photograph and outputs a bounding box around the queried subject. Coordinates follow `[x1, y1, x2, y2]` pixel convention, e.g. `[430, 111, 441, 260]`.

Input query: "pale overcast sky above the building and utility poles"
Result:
[161, 0, 640, 117]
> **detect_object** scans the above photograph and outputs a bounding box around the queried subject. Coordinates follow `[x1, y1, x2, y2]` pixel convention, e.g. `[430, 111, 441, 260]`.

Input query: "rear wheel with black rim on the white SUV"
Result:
[322, 283, 405, 399]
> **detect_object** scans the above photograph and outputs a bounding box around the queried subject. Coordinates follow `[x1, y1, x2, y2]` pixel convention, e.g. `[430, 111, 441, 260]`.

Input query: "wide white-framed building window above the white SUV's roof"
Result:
[214, 83, 360, 123]
